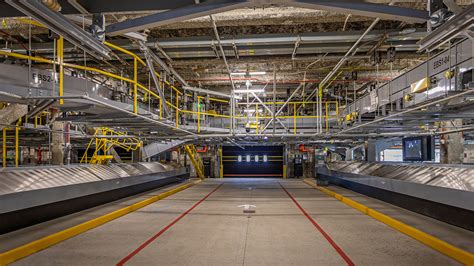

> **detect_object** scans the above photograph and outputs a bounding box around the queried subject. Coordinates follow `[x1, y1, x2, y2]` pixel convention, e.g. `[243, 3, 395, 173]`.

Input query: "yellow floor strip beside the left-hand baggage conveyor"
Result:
[0, 180, 201, 265]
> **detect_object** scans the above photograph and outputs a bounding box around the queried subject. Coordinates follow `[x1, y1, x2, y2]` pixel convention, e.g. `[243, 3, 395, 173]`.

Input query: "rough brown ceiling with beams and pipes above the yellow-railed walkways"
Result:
[0, 0, 472, 145]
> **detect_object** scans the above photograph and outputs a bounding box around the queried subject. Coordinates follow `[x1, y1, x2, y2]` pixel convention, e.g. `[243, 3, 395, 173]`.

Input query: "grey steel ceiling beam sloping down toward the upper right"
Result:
[289, 0, 429, 23]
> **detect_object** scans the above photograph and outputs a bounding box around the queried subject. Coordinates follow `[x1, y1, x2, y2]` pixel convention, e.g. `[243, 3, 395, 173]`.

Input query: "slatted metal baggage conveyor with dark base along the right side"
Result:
[316, 161, 474, 231]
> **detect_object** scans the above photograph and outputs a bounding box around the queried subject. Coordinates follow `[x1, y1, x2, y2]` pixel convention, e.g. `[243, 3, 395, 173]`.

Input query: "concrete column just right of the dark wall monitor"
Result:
[440, 119, 464, 164]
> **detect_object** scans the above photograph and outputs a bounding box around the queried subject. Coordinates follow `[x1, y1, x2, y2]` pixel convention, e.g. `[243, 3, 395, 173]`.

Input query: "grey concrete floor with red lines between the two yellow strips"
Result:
[15, 179, 457, 265]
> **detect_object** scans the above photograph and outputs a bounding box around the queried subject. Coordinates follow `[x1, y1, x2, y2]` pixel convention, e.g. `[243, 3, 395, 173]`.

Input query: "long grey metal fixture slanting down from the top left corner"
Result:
[5, 0, 111, 59]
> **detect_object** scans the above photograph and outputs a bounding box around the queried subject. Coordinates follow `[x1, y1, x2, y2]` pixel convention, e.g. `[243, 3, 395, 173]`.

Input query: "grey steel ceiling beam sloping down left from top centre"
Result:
[106, 0, 249, 36]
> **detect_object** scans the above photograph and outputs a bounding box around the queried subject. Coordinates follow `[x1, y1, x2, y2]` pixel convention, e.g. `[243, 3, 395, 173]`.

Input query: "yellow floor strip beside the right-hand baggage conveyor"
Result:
[304, 179, 474, 266]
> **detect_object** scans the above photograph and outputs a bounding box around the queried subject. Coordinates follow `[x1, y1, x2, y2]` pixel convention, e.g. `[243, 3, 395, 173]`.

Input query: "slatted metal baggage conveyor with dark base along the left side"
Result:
[0, 162, 189, 234]
